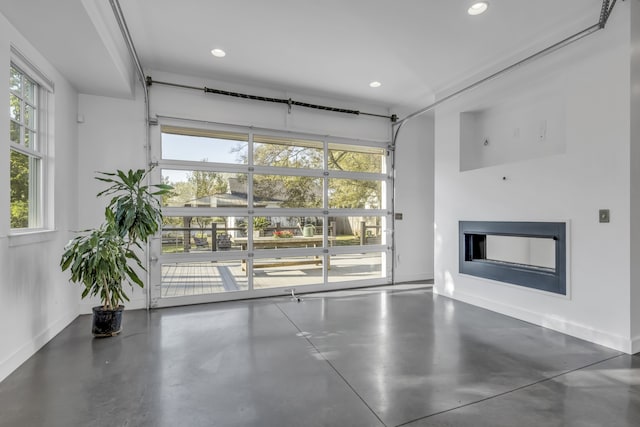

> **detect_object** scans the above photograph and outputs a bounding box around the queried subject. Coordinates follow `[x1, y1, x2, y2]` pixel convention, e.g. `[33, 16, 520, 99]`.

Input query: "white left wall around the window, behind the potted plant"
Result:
[0, 15, 80, 380]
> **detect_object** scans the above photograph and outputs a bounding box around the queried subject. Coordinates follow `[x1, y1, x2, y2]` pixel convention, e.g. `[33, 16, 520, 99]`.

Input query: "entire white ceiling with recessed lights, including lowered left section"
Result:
[0, 0, 602, 108]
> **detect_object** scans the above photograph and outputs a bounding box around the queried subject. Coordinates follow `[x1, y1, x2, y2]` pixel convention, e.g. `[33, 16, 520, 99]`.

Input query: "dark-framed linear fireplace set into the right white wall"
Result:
[459, 221, 567, 295]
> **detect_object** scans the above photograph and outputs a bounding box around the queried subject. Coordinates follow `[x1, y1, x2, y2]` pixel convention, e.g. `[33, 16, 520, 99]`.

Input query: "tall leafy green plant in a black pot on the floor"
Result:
[60, 169, 173, 336]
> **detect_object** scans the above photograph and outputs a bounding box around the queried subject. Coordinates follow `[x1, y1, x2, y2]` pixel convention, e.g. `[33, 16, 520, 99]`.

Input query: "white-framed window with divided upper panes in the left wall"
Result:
[9, 63, 46, 230]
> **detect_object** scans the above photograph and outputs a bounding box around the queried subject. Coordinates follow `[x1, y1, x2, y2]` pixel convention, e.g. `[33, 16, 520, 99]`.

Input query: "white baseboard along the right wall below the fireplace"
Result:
[433, 287, 640, 354]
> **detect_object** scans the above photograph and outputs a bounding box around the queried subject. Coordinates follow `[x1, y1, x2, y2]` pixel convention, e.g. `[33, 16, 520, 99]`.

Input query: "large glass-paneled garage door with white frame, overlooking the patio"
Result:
[150, 123, 391, 307]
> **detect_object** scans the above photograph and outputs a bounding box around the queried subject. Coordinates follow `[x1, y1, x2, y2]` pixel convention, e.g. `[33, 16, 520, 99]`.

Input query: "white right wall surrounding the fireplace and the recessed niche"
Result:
[435, 2, 632, 352]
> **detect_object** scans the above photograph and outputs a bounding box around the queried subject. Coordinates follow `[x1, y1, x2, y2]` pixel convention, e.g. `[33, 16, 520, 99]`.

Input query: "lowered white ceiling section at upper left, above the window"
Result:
[0, 0, 132, 97]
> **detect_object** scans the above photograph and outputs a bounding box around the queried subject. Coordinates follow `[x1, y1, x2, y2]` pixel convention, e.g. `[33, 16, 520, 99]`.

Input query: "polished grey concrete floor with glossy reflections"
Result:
[0, 286, 640, 427]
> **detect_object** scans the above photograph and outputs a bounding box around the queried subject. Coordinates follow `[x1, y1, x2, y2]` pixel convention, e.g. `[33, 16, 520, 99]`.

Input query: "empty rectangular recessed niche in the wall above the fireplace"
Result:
[460, 90, 566, 171]
